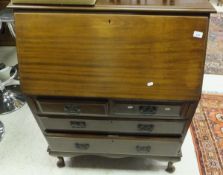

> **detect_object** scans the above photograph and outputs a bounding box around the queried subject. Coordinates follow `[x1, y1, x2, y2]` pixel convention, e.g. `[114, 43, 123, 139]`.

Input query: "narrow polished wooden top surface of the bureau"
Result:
[9, 0, 215, 13]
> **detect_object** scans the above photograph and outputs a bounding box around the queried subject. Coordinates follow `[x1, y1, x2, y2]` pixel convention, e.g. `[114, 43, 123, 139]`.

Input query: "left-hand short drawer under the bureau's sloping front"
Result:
[36, 99, 107, 115]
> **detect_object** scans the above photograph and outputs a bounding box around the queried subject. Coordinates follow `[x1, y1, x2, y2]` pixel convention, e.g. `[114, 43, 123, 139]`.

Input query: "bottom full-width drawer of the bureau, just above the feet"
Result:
[47, 136, 181, 156]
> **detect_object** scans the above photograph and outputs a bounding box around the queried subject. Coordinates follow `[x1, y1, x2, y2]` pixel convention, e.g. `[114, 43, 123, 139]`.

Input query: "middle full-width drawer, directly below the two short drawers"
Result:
[39, 117, 185, 135]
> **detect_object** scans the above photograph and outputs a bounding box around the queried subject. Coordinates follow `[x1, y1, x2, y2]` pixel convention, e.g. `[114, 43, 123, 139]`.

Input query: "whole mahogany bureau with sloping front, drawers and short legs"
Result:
[9, 0, 214, 172]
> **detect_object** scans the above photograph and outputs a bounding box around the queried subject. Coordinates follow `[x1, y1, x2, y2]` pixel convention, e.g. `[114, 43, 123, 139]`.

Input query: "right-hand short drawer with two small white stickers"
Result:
[110, 101, 186, 118]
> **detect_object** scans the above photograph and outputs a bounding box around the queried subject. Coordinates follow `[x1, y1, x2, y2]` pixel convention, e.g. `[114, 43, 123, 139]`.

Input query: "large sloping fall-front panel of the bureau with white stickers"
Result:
[15, 12, 208, 100]
